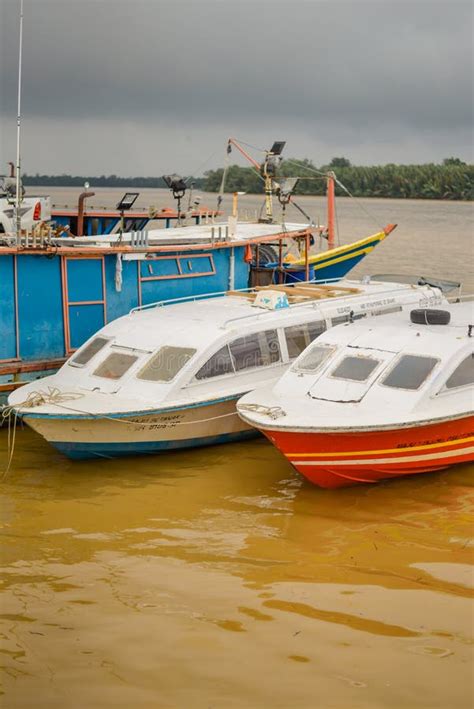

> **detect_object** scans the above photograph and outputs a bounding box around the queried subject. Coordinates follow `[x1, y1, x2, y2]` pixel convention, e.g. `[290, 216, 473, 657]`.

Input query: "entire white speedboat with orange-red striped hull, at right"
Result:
[237, 302, 474, 488]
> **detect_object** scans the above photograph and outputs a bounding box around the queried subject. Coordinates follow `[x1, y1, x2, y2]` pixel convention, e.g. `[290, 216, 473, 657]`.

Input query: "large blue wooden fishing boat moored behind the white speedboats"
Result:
[0, 143, 394, 400]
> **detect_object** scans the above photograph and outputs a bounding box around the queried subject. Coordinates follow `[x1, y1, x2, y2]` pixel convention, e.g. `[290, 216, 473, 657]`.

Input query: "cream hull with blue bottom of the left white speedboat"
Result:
[23, 397, 258, 460]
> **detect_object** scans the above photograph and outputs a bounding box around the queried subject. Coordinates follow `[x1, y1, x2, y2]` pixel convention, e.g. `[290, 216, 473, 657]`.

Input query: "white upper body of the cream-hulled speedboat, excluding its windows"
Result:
[9, 280, 452, 415]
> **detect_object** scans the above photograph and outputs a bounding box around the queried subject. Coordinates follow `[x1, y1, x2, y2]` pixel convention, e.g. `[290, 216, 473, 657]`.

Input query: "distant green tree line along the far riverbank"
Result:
[23, 157, 474, 200]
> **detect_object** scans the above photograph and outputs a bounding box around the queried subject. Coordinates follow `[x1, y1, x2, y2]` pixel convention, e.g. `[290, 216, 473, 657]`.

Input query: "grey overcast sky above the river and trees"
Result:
[0, 0, 473, 175]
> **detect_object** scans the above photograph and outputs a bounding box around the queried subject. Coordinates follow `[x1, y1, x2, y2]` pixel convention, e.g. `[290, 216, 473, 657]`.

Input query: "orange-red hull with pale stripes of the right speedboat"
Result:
[262, 416, 474, 488]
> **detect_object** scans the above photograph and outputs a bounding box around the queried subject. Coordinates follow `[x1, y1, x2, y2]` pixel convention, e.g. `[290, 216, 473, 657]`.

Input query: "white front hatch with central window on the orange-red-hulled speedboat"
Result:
[308, 347, 396, 403]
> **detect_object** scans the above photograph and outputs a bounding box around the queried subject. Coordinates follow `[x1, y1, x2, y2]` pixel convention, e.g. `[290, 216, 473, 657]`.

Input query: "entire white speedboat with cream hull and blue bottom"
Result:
[9, 279, 452, 458]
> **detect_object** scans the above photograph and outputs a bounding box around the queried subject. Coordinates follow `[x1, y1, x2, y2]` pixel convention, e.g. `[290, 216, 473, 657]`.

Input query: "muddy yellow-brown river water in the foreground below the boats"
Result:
[0, 429, 474, 709]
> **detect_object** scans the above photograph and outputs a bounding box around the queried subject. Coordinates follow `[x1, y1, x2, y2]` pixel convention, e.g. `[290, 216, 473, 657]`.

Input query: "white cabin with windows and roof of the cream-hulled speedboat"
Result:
[40, 281, 444, 409]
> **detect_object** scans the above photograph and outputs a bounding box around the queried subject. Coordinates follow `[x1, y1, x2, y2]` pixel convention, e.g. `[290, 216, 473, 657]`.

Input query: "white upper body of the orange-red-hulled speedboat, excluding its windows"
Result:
[239, 302, 474, 431]
